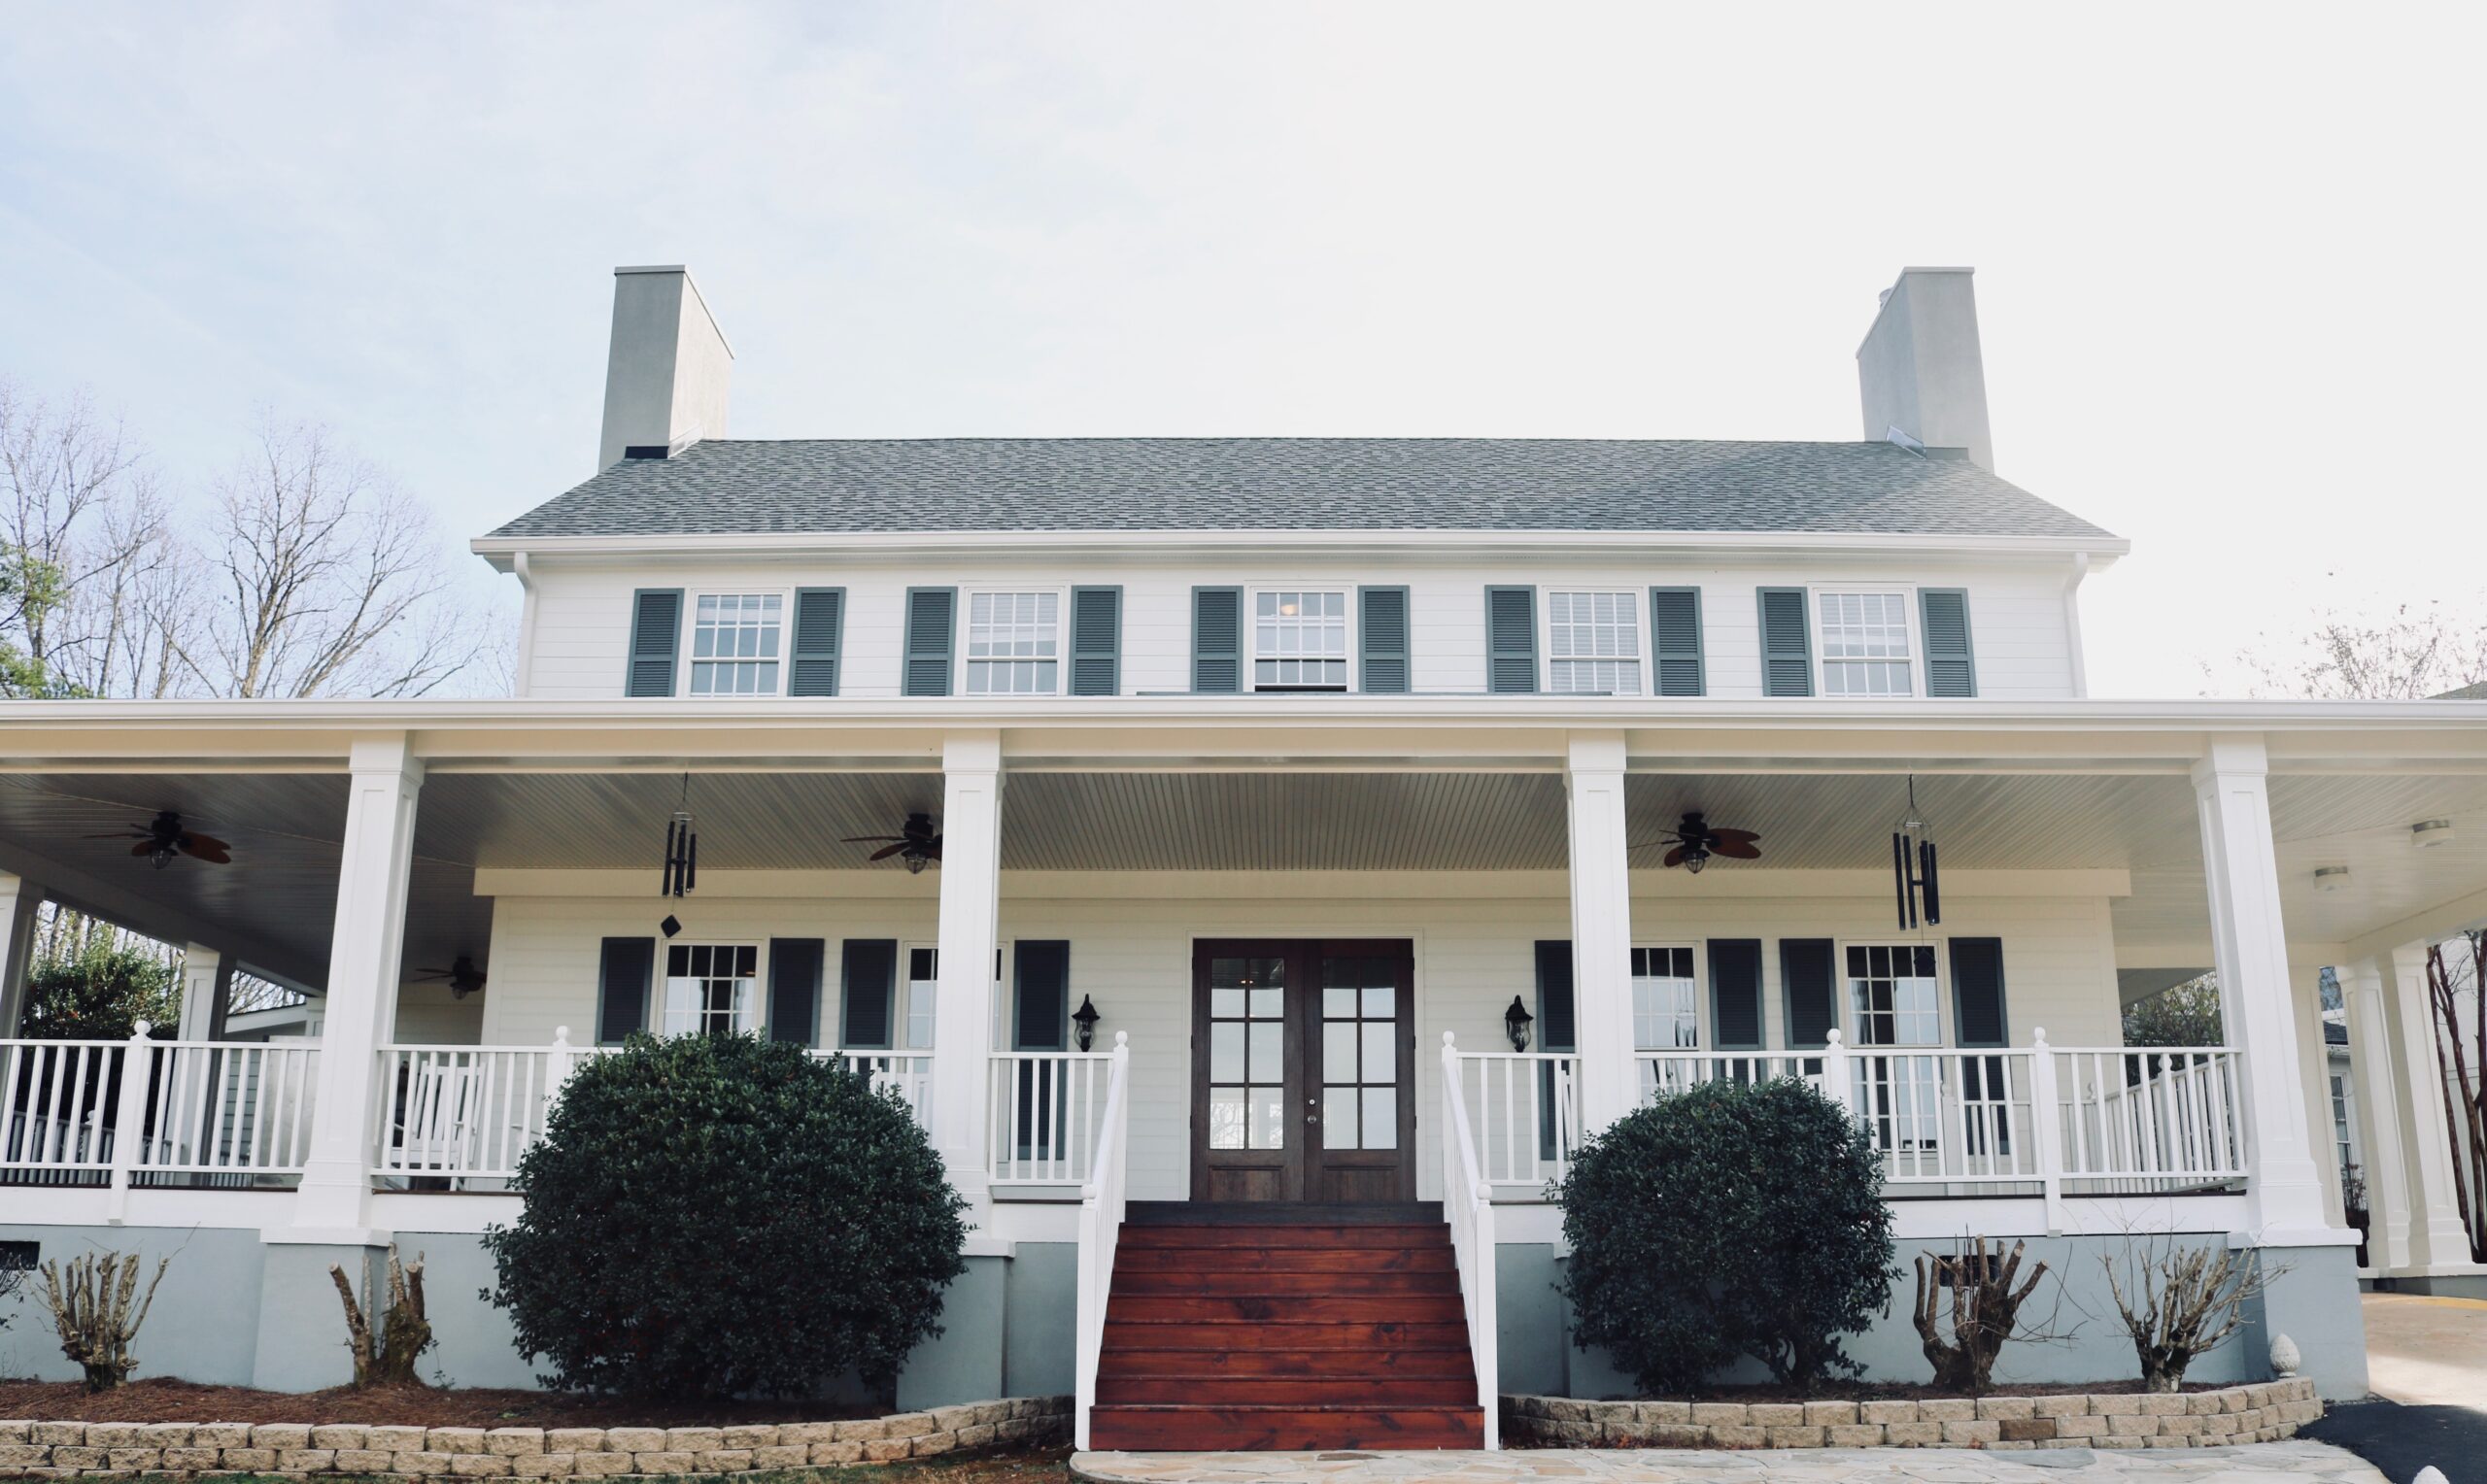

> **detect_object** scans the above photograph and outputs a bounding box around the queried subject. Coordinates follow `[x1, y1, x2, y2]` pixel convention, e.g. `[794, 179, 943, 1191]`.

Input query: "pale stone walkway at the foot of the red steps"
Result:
[1072, 1441, 2385, 1484]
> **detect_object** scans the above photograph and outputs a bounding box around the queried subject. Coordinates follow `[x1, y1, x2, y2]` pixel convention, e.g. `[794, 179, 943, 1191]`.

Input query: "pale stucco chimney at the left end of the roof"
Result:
[596, 263, 733, 470]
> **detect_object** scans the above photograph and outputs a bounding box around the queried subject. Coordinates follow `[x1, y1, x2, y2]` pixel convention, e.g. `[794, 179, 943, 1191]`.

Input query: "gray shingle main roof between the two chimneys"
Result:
[493, 437, 2106, 539]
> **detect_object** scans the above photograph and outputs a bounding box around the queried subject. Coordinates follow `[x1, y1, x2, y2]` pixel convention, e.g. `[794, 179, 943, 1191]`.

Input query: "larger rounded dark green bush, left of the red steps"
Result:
[485, 1036, 968, 1397]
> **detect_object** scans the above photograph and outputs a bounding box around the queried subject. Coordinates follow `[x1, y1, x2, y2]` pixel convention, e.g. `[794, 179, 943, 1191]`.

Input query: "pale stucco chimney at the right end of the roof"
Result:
[1857, 268, 1994, 470]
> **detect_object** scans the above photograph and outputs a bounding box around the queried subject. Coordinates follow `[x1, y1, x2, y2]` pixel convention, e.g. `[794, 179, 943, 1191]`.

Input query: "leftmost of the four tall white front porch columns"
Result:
[290, 736, 423, 1243]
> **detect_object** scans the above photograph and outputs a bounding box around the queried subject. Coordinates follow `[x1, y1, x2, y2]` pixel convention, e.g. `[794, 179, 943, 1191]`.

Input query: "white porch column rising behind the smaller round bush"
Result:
[1564, 730, 1639, 1133]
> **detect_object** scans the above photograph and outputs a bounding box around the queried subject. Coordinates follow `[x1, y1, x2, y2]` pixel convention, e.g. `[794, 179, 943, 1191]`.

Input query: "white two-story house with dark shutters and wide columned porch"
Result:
[0, 268, 2487, 1447]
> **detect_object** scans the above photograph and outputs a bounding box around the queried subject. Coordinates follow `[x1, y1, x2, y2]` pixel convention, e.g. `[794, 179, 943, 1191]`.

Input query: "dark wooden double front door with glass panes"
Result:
[1191, 939, 1415, 1200]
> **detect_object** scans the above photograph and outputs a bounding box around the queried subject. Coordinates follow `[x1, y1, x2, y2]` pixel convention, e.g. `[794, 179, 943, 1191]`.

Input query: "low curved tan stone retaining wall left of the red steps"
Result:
[0, 1397, 1072, 1479]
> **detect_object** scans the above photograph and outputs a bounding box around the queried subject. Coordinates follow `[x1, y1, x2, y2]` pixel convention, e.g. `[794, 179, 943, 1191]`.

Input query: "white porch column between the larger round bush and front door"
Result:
[933, 730, 1003, 1221]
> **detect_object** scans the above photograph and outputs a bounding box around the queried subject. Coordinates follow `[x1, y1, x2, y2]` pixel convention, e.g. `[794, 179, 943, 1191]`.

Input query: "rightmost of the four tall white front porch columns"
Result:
[2194, 738, 2348, 1248]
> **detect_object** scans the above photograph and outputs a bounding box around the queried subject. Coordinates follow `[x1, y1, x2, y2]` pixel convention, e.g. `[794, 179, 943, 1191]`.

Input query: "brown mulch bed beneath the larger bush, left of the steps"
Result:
[0, 1380, 898, 1427]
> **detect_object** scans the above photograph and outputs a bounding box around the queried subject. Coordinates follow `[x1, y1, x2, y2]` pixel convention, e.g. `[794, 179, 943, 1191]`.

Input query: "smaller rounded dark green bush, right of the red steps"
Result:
[1554, 1079, 1900, 1395]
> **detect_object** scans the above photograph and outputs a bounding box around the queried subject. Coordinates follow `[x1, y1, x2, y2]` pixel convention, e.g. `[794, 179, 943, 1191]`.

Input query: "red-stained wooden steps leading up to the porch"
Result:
[1089, 1200, 1484, 1449]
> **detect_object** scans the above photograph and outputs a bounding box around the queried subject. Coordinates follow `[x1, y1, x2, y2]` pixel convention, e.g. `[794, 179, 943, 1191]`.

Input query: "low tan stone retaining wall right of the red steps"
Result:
[1502, 1377, 2323, 1449]
